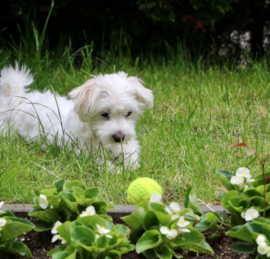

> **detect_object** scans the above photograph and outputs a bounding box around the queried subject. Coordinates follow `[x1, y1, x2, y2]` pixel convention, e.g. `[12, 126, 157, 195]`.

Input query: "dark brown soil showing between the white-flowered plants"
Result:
[0, 214, 249, 259]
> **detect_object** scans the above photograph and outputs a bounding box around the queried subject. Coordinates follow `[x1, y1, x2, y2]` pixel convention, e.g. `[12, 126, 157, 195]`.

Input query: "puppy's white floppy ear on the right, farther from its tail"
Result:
[127, 76, 154, 109]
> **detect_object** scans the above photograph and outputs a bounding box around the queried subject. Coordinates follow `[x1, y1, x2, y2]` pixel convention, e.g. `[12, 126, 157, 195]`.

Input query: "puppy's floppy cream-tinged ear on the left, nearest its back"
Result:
[68, 78, 98, 122]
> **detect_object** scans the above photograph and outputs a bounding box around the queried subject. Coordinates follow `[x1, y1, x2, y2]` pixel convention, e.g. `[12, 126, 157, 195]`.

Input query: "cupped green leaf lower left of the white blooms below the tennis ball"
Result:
[136, 230, 162, 254]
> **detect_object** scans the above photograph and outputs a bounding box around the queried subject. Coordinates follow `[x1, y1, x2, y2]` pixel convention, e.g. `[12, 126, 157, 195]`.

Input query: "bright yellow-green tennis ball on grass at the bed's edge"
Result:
[127, 177, 162, 204]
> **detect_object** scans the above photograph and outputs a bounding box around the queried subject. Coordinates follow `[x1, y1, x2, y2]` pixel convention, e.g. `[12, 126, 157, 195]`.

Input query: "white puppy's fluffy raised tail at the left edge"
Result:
[0, 62, 33, 98]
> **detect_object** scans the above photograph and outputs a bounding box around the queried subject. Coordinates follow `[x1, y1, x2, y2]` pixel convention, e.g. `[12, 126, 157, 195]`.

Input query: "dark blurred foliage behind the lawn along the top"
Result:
[0, 0, 270, 62]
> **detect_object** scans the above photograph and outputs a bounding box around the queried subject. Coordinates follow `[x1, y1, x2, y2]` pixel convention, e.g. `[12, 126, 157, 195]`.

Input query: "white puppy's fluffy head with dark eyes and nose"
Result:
[69, 72, 154, 145]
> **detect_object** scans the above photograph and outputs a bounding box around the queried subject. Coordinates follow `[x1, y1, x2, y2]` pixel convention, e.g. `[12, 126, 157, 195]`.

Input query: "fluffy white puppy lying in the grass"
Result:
[0, 64, 154, 168]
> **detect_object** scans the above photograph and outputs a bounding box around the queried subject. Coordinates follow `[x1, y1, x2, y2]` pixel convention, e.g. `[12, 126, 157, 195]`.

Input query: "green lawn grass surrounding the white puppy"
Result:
[0, 43, 270, 207]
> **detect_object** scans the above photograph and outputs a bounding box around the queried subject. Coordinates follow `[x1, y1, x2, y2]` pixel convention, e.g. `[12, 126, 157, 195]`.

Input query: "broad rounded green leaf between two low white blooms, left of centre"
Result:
[71, 226, 95, 248]
